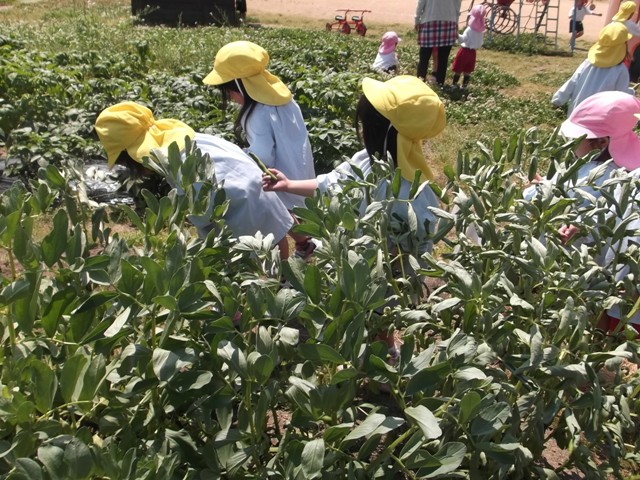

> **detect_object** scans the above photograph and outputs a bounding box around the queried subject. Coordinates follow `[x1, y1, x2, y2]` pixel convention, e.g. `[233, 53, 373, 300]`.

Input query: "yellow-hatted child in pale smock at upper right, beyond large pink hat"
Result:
[551, 22, 633, 114]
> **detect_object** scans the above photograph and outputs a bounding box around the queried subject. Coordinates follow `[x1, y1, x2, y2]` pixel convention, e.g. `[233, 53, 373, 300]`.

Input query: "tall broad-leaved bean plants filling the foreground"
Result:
[0, 125, 640, 479]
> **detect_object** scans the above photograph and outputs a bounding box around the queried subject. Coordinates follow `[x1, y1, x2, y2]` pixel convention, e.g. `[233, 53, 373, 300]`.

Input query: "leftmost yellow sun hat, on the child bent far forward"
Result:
[95, 102, 195, 168]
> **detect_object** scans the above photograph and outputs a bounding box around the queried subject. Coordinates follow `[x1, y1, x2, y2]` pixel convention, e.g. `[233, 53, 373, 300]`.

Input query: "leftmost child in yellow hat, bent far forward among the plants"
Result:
[95, 102, 293, 258]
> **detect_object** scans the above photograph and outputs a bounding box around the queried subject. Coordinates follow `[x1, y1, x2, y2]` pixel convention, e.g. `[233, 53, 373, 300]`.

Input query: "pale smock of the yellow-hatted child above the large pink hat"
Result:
[551, 59, 634, 114]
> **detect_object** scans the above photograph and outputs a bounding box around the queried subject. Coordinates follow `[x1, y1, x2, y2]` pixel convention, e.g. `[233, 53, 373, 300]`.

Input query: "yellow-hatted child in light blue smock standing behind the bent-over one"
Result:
[203, 41, 316, 258]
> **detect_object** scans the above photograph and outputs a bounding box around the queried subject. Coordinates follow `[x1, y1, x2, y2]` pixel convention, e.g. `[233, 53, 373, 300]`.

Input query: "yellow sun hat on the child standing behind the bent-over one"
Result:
[202, 40, 292, 106]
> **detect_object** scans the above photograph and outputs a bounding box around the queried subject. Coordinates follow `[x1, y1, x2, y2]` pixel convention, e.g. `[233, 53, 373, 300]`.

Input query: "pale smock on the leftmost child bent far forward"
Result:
[167, 133, 293, 242]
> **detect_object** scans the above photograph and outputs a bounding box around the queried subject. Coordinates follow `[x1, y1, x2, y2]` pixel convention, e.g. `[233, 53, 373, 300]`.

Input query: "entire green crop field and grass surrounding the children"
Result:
[0, 2, 640, 480]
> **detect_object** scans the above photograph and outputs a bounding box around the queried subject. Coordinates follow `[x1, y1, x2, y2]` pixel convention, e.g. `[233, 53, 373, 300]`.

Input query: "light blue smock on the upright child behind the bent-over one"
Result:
[243, 100, 316, 210]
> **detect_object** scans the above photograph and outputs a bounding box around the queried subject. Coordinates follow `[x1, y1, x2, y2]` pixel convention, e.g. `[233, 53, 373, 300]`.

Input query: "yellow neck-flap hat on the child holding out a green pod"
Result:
[362, 75, 447, 181]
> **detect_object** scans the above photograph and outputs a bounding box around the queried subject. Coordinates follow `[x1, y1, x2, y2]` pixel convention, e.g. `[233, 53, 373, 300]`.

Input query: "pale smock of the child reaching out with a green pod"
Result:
[316, 150, 439, 253]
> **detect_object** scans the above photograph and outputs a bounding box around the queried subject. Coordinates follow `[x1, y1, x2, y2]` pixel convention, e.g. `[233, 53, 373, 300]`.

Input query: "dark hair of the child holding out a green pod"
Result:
[355, 95, 398, 166]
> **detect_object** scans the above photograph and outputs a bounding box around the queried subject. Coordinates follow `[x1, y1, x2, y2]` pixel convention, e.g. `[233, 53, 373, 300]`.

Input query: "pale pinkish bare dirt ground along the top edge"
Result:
[247, 0, 609, 41]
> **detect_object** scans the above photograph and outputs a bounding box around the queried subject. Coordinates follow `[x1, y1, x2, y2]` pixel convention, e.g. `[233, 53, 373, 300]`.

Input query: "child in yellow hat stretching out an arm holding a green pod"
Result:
[262, 75, 446, 356]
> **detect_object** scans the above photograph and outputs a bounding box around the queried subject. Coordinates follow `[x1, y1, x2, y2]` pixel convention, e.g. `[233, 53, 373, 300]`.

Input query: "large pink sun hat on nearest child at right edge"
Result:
[560, 91, 640, 171]
